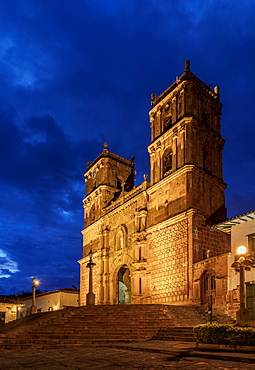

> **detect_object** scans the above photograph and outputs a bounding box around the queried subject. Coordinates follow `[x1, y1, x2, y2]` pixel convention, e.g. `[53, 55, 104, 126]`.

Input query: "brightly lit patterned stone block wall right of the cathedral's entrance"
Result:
[148, 220, 188, 303]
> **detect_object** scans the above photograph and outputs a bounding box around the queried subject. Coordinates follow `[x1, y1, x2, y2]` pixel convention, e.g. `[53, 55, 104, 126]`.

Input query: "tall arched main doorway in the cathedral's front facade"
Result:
[117, 265, 131, 304]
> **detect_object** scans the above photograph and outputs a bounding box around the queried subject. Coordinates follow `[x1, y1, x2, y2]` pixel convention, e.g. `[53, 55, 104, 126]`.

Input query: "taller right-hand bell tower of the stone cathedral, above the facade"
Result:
[148, 61, 226, 222]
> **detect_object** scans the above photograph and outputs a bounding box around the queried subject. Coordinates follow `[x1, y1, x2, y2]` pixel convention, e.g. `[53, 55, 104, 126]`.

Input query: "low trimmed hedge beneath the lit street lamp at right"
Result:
[194, 323, 255, 346]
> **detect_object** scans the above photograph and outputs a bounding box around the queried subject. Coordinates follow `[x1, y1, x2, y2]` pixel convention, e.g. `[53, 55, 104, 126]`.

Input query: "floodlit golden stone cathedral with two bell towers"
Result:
[79, 61, 230, 305]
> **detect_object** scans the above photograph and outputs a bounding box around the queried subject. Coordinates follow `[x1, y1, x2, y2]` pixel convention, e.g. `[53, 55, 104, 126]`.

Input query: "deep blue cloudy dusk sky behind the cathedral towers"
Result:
[0, 0, 255, 294]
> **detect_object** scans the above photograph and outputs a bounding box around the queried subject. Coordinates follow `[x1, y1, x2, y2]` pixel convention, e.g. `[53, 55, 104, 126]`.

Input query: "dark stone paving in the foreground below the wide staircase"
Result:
[0, 341, 255, 370]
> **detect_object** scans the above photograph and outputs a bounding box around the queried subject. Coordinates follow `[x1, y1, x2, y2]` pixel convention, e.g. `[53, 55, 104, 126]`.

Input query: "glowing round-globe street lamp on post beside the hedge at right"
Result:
[231, 246, 253, 326]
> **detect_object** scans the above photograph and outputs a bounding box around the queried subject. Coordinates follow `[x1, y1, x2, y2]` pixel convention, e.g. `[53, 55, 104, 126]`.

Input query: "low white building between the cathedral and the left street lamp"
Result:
[20, 288, 80, 316]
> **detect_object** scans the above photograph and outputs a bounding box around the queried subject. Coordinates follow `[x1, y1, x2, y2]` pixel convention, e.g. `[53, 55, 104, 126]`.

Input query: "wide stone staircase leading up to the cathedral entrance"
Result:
[0, 304, 208, 348]
